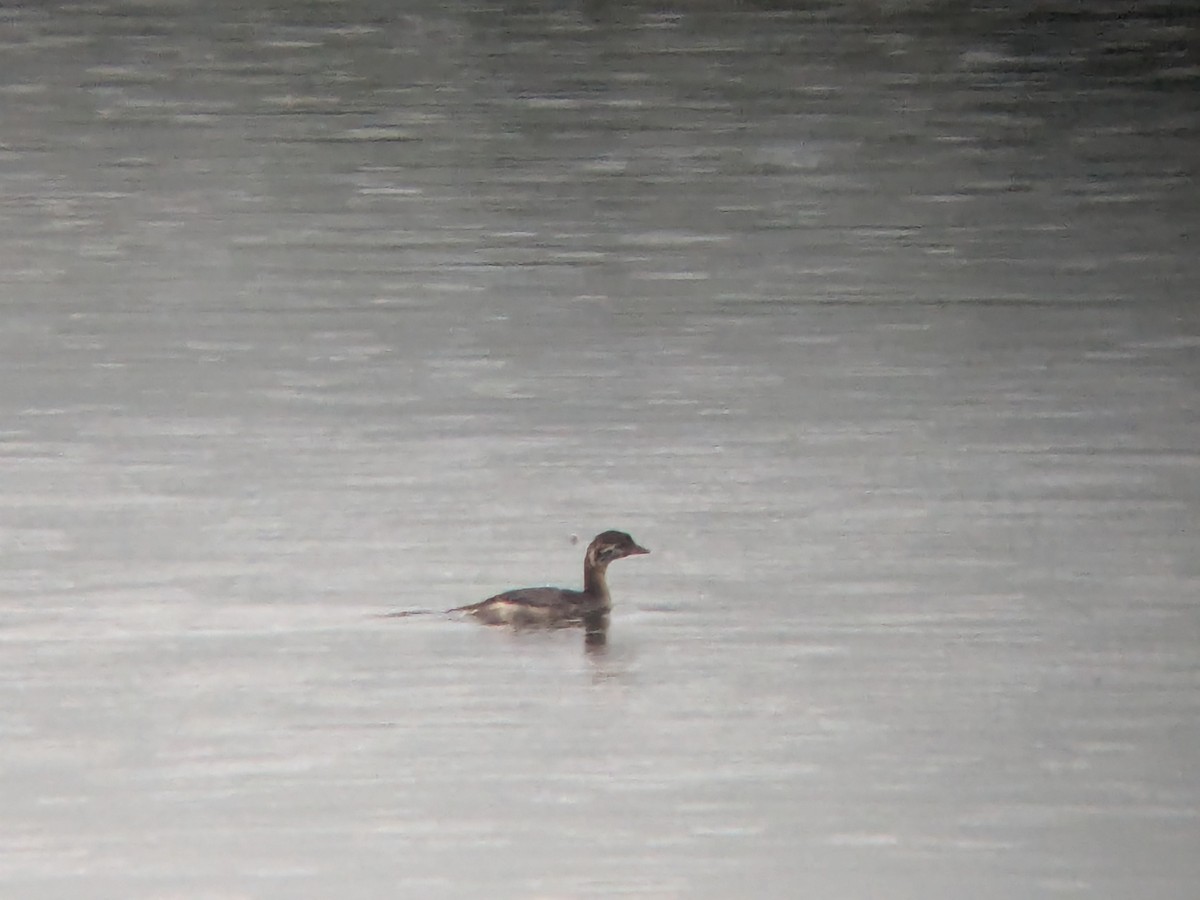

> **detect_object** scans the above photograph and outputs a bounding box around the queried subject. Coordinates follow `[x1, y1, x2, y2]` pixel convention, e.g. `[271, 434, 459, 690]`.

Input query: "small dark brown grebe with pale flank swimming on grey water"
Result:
[449, 532, 650, 632]
